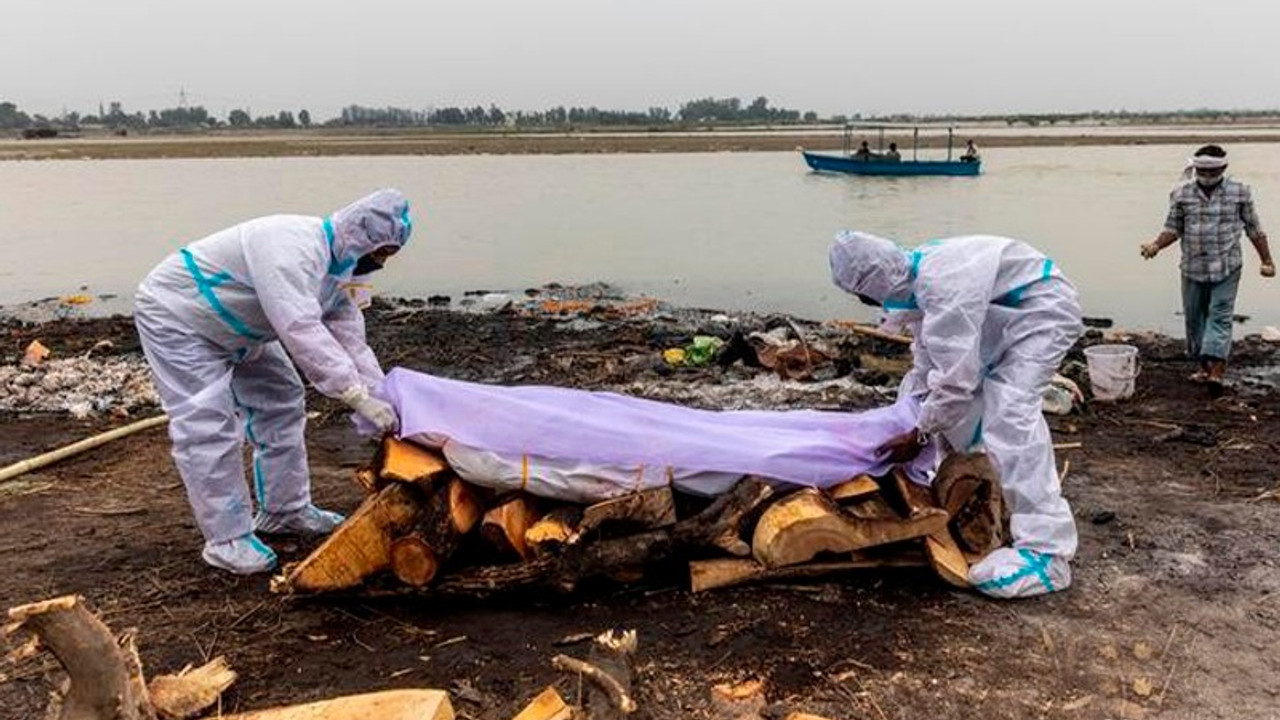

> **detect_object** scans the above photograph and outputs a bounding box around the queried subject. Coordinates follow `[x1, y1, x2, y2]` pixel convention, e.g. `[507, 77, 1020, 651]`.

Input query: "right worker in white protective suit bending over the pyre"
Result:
[831, 231, 1083, 597]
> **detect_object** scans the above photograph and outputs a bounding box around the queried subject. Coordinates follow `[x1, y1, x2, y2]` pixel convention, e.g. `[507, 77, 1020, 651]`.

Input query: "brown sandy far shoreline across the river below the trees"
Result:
[0, 126, 1280, 160]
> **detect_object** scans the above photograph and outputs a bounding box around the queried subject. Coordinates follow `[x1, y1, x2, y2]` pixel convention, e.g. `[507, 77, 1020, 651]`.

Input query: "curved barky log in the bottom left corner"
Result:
[9, 596, 155, 720]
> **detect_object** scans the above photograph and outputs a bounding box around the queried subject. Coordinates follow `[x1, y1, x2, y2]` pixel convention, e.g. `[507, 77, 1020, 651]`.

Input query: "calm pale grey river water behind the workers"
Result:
[0, 143, 1280, 332]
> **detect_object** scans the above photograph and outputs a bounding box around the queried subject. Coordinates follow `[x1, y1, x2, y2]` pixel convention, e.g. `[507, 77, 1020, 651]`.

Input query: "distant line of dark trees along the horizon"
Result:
[0, 96, 1280, 135]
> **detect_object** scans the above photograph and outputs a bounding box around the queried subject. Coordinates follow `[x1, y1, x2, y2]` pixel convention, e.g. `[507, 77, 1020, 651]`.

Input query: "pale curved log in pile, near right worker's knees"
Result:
[751, 488, 947, 568]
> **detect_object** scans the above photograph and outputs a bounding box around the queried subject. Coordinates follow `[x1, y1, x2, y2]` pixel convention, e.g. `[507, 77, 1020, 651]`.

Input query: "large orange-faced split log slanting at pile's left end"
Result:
[271, 483, 425, 593]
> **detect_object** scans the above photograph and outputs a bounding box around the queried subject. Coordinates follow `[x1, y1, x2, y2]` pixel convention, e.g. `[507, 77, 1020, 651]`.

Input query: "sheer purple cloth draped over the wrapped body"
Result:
[383, 368, 934, 487]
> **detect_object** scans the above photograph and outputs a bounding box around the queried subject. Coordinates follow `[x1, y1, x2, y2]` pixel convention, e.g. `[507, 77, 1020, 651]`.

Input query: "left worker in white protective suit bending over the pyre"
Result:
[134, 190, 412, 574]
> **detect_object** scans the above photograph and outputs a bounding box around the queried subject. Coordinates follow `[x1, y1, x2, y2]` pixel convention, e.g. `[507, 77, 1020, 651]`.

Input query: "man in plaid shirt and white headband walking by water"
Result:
[1142, 145, 1276, 388]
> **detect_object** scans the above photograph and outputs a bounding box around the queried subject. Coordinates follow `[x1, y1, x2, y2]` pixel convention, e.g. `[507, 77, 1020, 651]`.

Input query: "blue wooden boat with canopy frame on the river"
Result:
[800, 124, 982, 176]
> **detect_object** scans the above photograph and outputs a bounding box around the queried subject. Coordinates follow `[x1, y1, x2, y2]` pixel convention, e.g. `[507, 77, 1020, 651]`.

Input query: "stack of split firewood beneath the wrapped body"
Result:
[273, 438, 1006, 596]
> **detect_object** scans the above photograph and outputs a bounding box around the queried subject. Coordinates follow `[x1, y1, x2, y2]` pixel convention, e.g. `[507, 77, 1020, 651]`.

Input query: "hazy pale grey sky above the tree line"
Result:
[0, 0, 1280, 119]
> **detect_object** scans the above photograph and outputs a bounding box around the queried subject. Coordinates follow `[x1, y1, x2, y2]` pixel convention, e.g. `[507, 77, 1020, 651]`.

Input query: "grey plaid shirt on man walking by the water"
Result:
[1165, 178, 1262, 282]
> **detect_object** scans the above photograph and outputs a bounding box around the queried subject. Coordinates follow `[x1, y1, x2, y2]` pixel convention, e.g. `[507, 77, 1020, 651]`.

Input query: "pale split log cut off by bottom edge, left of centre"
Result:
[221, 691, 454, 720]
